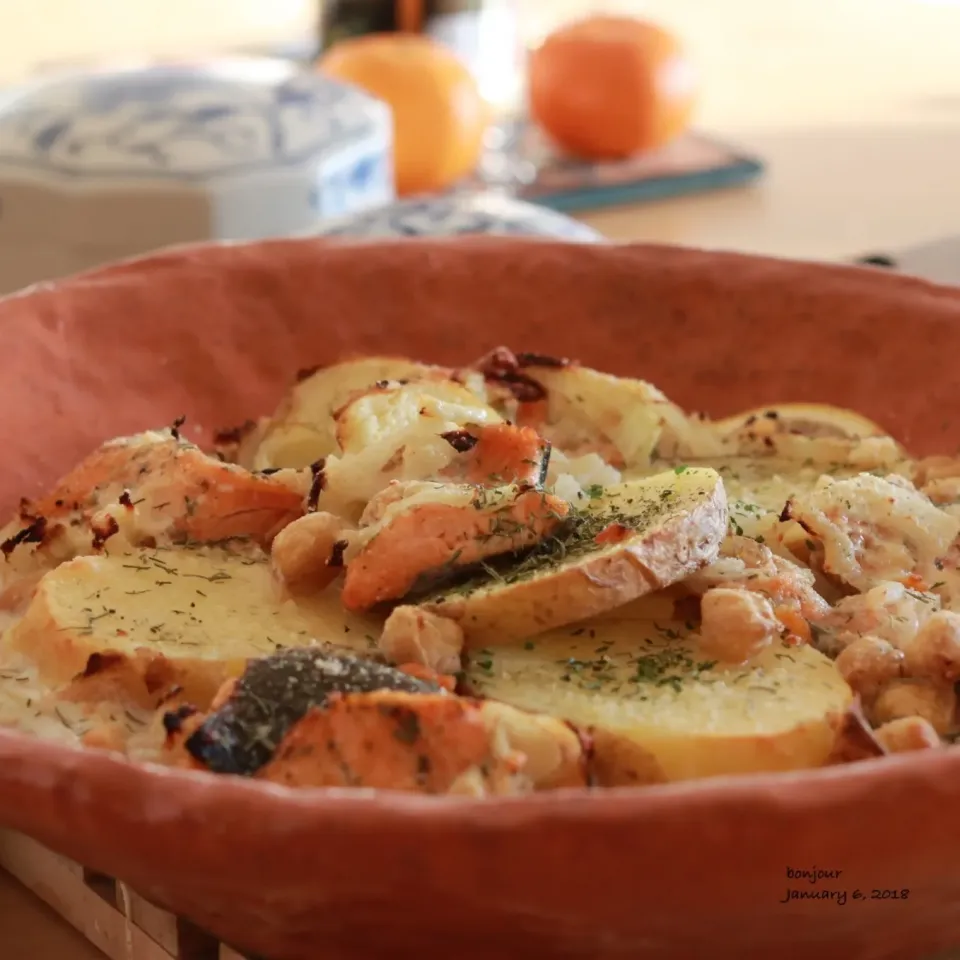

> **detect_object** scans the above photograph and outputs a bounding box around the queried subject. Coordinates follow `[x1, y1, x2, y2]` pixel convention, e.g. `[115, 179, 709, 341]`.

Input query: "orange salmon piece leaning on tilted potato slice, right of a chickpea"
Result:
[342, 483, 569, 610]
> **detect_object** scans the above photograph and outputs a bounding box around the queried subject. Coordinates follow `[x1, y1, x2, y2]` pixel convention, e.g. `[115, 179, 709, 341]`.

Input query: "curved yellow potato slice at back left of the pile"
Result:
[252, 357, 452, 470]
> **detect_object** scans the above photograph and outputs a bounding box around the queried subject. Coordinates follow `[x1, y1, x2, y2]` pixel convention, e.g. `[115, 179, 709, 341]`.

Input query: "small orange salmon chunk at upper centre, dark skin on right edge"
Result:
[441, 423, 550, 487]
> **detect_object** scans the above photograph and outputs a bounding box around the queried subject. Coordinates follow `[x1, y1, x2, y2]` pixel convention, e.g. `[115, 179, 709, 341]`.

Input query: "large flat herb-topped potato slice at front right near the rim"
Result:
[466, 618, 854, 786]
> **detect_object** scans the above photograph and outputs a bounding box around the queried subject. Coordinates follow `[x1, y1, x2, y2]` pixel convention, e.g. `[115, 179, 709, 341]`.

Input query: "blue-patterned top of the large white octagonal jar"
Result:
[0, 59, 389, 179]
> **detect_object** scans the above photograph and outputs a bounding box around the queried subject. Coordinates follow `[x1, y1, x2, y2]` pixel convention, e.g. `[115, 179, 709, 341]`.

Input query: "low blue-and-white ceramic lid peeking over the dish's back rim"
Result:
[312, 192, 604, 243]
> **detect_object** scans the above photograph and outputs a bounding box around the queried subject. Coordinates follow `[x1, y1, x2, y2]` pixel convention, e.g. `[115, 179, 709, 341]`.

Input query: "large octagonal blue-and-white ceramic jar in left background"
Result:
[0, 59, 394, 293]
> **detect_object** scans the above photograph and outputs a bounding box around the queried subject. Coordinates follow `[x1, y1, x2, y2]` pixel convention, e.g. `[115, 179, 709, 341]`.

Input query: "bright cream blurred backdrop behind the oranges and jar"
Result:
[0, 0, 960, 131]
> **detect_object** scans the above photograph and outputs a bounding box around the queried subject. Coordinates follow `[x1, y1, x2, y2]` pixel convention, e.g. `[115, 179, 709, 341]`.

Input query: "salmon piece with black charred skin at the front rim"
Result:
[164, 647, 586, 796]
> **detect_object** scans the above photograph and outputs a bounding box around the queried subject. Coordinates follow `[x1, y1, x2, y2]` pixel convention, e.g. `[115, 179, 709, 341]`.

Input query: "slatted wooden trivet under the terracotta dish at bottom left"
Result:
[0, 830, 256, 960]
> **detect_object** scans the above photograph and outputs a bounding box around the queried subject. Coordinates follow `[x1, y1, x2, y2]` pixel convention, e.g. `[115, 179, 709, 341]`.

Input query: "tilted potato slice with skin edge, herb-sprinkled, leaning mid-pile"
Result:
[423, 467, 727, 647]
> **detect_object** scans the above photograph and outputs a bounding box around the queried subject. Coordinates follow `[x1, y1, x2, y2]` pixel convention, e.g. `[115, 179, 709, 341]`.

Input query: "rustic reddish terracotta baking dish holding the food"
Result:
[0, 239, 960, 960]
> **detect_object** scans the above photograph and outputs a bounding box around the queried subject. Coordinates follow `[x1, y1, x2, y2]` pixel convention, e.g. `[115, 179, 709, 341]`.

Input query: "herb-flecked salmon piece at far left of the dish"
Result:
[4, 428, 309, 542]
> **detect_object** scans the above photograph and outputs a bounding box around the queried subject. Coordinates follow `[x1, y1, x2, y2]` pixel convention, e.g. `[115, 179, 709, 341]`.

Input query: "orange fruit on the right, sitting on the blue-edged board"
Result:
[529, 16, 696, 160]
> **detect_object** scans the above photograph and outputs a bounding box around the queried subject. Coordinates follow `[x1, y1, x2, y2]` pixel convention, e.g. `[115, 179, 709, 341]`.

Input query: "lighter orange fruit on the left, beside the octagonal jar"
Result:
[318, 33, 490, 196]
